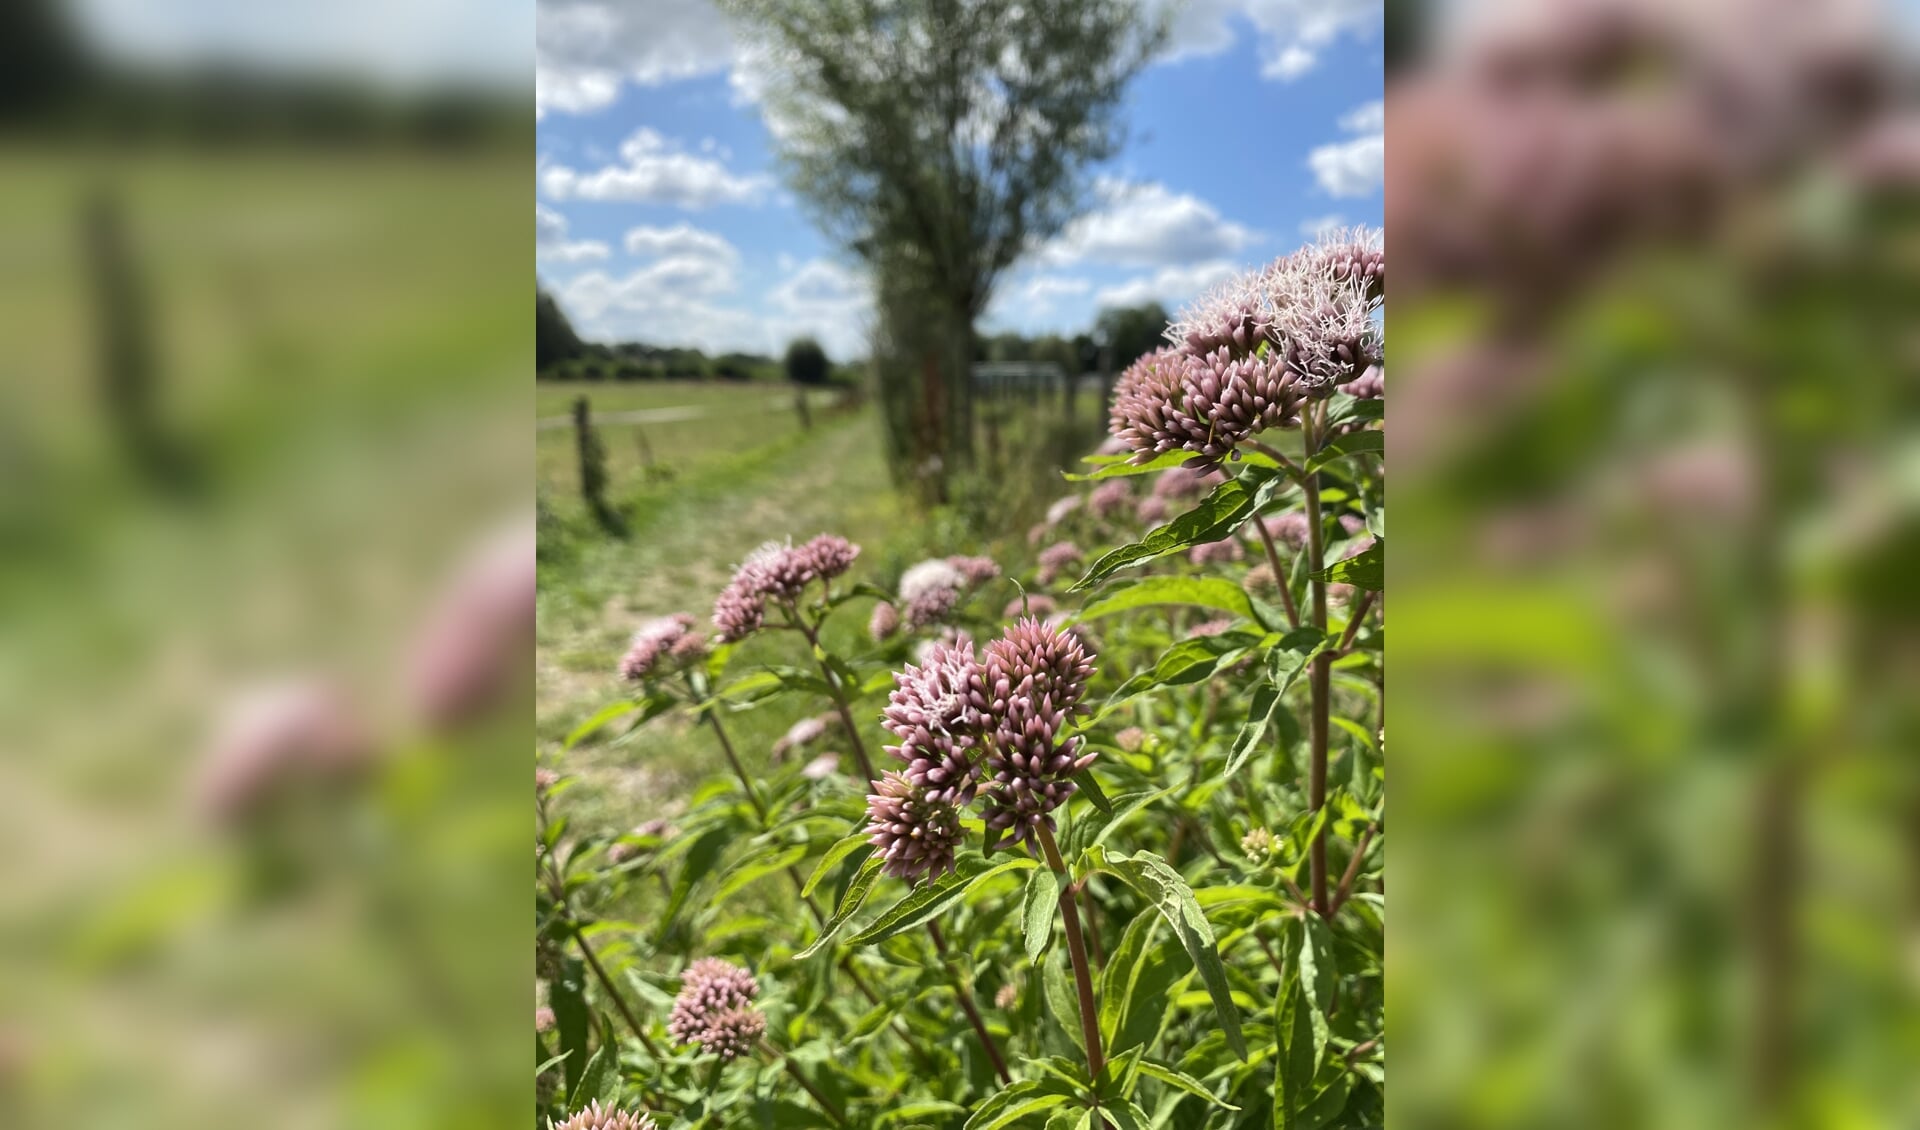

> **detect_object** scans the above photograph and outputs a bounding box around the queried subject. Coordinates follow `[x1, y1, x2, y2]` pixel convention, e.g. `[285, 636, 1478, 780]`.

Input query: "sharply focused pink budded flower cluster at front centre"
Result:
[866, 616, 1094, 879]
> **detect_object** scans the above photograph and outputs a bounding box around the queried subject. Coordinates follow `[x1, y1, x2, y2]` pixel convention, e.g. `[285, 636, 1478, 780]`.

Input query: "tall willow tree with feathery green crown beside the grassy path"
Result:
[722, 0, 1165, 494]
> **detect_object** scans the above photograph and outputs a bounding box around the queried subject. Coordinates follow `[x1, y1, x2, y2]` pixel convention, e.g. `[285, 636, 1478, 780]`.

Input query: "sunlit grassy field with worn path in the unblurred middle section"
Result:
[536, 386, 1092, 831]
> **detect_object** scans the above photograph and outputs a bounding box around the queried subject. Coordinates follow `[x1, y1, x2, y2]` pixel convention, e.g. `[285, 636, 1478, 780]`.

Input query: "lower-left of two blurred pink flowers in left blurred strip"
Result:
[194, 677, 372, 821]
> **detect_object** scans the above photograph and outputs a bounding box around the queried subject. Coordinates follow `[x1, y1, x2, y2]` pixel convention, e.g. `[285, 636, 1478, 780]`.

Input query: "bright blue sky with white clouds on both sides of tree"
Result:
[536, 0, 1384, 357]
